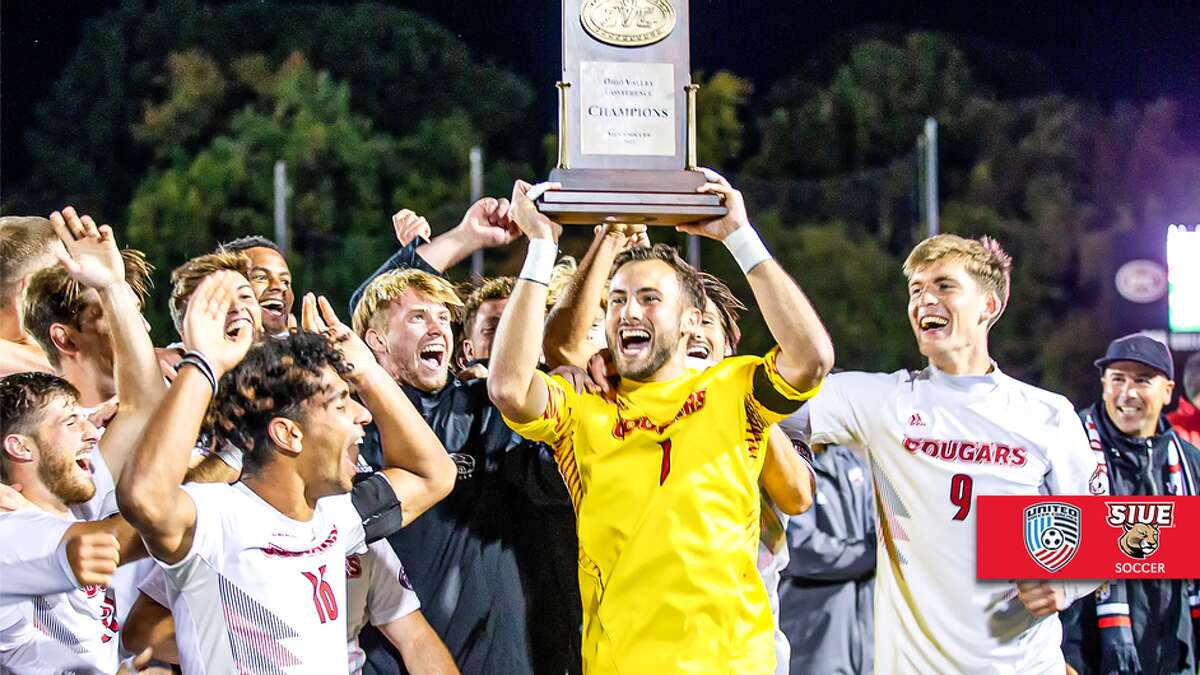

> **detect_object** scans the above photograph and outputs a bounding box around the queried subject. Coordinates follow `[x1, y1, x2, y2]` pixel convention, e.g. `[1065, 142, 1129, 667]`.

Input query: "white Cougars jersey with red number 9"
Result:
[802, 366, 1097, 675]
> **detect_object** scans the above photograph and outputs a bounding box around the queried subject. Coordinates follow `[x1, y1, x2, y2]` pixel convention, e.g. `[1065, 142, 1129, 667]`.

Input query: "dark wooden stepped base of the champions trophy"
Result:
[536, 169, 727, 227]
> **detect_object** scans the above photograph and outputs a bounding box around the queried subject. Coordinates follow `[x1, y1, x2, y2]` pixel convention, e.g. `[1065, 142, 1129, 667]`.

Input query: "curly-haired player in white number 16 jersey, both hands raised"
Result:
[118, 271, 454, 673]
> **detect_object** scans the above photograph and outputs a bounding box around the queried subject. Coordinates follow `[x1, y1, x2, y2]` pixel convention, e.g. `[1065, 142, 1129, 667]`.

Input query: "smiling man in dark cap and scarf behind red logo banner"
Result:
[1063, 335, 1200, 675]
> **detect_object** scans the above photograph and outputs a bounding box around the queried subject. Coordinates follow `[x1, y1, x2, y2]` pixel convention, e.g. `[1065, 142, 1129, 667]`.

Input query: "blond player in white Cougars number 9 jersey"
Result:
[787, 234, 1097, 674]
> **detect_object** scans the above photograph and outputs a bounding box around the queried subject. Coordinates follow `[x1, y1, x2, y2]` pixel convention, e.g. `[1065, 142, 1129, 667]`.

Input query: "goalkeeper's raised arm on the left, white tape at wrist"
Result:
[487, 180, 563, 423]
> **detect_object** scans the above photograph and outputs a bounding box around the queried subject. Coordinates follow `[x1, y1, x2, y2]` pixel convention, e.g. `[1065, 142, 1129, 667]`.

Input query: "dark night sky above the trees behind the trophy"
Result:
[0, 0, 1200, 183]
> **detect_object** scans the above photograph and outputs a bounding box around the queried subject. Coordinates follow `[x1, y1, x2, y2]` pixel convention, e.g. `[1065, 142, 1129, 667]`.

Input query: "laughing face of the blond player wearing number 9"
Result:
[908, 258, 1000, 370]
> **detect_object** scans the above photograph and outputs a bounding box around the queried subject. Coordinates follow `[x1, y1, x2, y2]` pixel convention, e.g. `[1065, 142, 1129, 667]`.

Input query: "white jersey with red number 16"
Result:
[160, 483, 366, 675]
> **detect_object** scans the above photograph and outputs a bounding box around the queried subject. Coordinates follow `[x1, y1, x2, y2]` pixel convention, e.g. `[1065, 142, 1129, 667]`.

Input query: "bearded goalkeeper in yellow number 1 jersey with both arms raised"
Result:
[488, 177, 833, 673]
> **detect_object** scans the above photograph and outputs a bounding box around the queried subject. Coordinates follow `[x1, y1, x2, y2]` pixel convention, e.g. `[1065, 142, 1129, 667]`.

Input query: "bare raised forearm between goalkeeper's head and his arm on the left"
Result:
[542, 225, 647, 368]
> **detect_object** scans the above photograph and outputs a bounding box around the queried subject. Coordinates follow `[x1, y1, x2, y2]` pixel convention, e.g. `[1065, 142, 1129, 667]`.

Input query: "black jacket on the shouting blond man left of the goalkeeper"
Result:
[361, 377, 582, 675]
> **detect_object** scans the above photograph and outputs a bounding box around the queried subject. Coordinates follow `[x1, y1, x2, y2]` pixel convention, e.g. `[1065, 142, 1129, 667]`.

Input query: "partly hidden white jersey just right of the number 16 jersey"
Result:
[346, 539, 421, 675]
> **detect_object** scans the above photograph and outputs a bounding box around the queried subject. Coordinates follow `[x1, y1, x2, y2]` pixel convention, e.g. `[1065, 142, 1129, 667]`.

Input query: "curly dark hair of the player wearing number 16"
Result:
[205, 330, 347, 473]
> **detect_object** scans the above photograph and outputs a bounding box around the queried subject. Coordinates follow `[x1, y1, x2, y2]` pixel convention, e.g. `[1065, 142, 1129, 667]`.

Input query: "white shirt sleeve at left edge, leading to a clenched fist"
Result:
[0, 508, 79, 605]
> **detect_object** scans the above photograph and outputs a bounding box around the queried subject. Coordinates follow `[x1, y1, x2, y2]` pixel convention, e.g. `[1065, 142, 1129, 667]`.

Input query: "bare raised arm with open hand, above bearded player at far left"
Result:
[50, 207, 167, 478]
